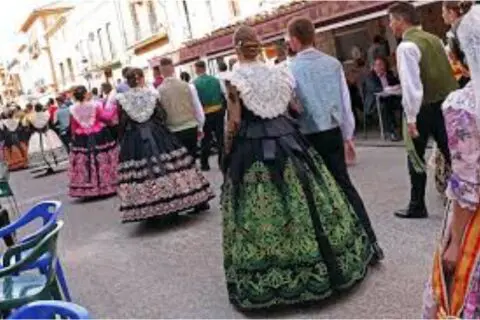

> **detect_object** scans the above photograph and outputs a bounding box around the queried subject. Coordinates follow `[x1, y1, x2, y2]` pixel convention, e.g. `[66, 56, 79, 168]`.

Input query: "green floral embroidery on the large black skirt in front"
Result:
[221, 156, 372, 309]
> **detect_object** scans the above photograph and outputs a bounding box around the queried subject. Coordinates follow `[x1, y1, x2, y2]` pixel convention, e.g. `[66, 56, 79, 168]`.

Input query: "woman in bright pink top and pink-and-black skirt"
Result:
[69, 86, 118, 198]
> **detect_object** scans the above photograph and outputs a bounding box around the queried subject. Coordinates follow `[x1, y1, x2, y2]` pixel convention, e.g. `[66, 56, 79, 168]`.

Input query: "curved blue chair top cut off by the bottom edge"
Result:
[8, 301, 90, 319]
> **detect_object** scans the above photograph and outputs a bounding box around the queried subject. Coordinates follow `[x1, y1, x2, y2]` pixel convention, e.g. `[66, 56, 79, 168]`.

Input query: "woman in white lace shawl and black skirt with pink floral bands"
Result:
[117, 69, 214, 222]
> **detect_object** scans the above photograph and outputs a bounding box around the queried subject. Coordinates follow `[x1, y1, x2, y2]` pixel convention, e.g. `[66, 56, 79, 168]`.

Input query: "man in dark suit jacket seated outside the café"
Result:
[362, 57, 402, 141]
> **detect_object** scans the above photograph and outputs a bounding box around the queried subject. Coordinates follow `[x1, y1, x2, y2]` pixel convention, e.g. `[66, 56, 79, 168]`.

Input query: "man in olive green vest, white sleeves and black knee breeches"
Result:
[389, 2, 457, 218]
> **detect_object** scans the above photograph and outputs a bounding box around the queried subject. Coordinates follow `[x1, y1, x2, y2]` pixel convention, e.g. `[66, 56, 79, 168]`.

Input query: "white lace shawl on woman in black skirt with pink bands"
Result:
[117, 88, 159, 123]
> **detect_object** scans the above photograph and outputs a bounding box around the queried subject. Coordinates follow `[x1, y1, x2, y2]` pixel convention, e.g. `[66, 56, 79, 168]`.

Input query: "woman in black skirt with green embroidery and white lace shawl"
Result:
[221, 27, 373, 309]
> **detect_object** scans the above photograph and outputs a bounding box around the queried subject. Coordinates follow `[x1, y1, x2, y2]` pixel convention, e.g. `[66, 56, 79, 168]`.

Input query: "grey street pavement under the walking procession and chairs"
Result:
[6, 148, 443, 318]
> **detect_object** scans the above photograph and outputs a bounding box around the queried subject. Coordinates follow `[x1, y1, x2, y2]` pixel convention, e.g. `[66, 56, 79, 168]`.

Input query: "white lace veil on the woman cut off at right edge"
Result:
[452, 4, 480, 128]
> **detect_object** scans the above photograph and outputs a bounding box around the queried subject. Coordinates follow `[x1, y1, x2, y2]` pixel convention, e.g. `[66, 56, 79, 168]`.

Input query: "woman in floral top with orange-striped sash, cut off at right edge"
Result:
[423, 5, 480, 319]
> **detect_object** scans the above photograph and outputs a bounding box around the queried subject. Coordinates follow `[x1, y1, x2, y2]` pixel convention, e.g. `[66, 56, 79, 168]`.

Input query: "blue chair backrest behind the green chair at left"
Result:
[0, 201, 62, 242]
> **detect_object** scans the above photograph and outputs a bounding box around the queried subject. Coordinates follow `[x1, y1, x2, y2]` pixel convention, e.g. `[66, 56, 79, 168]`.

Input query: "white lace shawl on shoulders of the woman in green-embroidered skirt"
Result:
[230, 62, 295, 119]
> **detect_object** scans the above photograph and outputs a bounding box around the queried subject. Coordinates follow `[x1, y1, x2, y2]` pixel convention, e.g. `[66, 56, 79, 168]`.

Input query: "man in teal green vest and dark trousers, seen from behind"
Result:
[193, 60, 225, 171]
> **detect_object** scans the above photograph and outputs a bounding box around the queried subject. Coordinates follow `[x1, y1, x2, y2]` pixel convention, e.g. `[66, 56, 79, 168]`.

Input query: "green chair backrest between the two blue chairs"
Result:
[0, 220, 63, 284]
